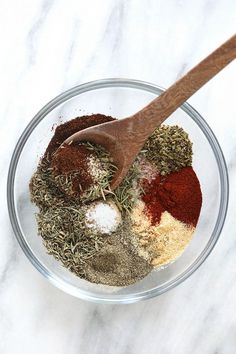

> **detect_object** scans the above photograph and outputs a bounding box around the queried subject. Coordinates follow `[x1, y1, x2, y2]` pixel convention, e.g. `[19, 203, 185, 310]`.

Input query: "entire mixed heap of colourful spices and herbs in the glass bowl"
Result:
[29, 114, 202, 287]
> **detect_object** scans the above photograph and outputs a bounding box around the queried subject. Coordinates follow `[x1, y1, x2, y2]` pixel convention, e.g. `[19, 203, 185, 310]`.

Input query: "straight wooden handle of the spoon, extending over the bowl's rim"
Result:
[132, 34, 236, 139]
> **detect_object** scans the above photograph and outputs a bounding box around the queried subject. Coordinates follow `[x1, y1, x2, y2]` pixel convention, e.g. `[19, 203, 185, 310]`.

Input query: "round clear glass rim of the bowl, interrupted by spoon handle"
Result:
[7, 78, 229, 304]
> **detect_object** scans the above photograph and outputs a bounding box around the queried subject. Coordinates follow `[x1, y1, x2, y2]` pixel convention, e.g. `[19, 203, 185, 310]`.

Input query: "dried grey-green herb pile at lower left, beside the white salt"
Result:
[37, 202, 106, 277]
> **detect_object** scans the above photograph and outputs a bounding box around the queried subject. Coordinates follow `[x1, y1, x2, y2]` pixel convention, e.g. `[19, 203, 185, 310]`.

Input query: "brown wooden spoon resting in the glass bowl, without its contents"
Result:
[63, 35, 236, 189]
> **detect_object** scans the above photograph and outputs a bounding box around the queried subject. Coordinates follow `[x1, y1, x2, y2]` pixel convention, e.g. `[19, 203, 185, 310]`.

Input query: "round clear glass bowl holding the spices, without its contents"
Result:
[7, 79, 229, 303]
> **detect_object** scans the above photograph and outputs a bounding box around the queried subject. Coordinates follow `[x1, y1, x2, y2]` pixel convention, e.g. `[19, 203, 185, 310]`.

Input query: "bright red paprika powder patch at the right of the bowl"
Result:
[142, 167, 202, 226]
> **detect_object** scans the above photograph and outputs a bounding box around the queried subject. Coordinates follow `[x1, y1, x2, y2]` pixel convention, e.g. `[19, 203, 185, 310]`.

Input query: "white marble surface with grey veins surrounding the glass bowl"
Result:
[0, 0, 236, 354]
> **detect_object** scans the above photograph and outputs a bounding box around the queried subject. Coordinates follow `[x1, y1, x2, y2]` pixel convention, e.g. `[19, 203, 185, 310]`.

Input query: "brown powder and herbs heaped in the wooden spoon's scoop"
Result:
[51, 143, 116, 201]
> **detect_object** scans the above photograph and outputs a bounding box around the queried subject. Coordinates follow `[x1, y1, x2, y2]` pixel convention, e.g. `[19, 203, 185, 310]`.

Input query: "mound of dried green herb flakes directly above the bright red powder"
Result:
[142, 125, 193, 175]
